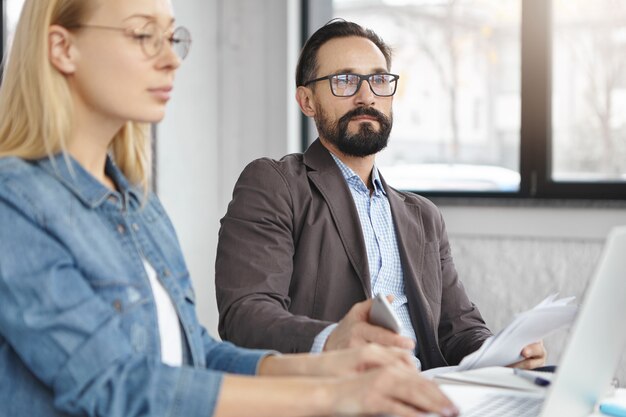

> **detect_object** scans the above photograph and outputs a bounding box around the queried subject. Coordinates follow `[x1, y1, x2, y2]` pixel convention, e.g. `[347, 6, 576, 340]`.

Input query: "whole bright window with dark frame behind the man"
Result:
[303, 0, 626, 199]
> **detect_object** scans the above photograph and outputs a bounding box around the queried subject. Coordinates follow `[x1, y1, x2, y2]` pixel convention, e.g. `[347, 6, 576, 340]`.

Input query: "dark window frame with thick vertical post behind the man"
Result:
[301, 0, 626, 201]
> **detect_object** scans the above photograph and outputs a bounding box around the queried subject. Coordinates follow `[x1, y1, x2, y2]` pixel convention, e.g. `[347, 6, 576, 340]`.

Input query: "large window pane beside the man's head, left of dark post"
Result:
[333, 0, 521, 192]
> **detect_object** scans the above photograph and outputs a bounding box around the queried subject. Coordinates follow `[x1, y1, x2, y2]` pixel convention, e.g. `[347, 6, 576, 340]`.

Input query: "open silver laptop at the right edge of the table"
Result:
[442, 226, 626, 417]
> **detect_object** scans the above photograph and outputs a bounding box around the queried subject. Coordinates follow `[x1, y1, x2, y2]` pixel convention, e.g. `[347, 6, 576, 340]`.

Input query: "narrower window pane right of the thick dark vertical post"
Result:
[551, 0, 626, 182]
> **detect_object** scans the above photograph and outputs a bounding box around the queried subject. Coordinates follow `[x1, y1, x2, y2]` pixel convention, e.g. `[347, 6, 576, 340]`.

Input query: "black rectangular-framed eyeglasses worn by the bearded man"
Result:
[304, 73, 400, 97]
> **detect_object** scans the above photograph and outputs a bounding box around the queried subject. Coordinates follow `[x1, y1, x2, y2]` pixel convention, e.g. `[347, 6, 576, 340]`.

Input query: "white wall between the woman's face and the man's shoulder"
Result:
[157, 0, 299, 337]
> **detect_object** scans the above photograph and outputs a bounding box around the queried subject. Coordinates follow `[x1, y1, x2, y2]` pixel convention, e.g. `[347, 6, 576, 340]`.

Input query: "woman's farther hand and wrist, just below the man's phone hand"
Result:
[258, 343, 416, 377]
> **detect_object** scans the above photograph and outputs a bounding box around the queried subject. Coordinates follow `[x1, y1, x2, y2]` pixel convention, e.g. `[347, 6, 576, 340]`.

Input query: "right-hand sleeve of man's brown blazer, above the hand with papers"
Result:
[438, 212, 491, 365]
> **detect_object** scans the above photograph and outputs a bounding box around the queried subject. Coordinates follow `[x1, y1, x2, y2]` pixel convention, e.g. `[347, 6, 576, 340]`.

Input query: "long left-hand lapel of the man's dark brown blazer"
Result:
[304, 139, 372, 298]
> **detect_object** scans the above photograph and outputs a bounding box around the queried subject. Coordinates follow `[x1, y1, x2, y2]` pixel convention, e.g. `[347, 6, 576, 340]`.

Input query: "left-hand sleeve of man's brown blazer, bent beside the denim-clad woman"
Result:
[215, 159, 331, 353]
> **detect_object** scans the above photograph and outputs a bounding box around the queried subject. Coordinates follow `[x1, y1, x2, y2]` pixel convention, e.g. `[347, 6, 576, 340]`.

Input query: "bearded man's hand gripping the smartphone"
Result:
[324, 299, 415, 351]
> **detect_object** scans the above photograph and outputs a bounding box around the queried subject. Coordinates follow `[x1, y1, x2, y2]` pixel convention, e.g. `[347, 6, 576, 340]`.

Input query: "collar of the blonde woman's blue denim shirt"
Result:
[36, 152, 143, 208]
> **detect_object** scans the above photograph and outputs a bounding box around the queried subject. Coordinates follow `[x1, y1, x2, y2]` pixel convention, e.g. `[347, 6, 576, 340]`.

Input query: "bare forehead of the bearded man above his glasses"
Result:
[317, 36, 387, 76]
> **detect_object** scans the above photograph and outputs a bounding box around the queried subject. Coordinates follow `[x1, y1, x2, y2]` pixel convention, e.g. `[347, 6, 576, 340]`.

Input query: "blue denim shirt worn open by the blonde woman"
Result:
[0, 155, 267, 417]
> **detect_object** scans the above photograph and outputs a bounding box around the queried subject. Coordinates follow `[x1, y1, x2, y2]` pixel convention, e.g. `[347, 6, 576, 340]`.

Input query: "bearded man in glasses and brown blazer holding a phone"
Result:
[215, 20, 545, 369]
